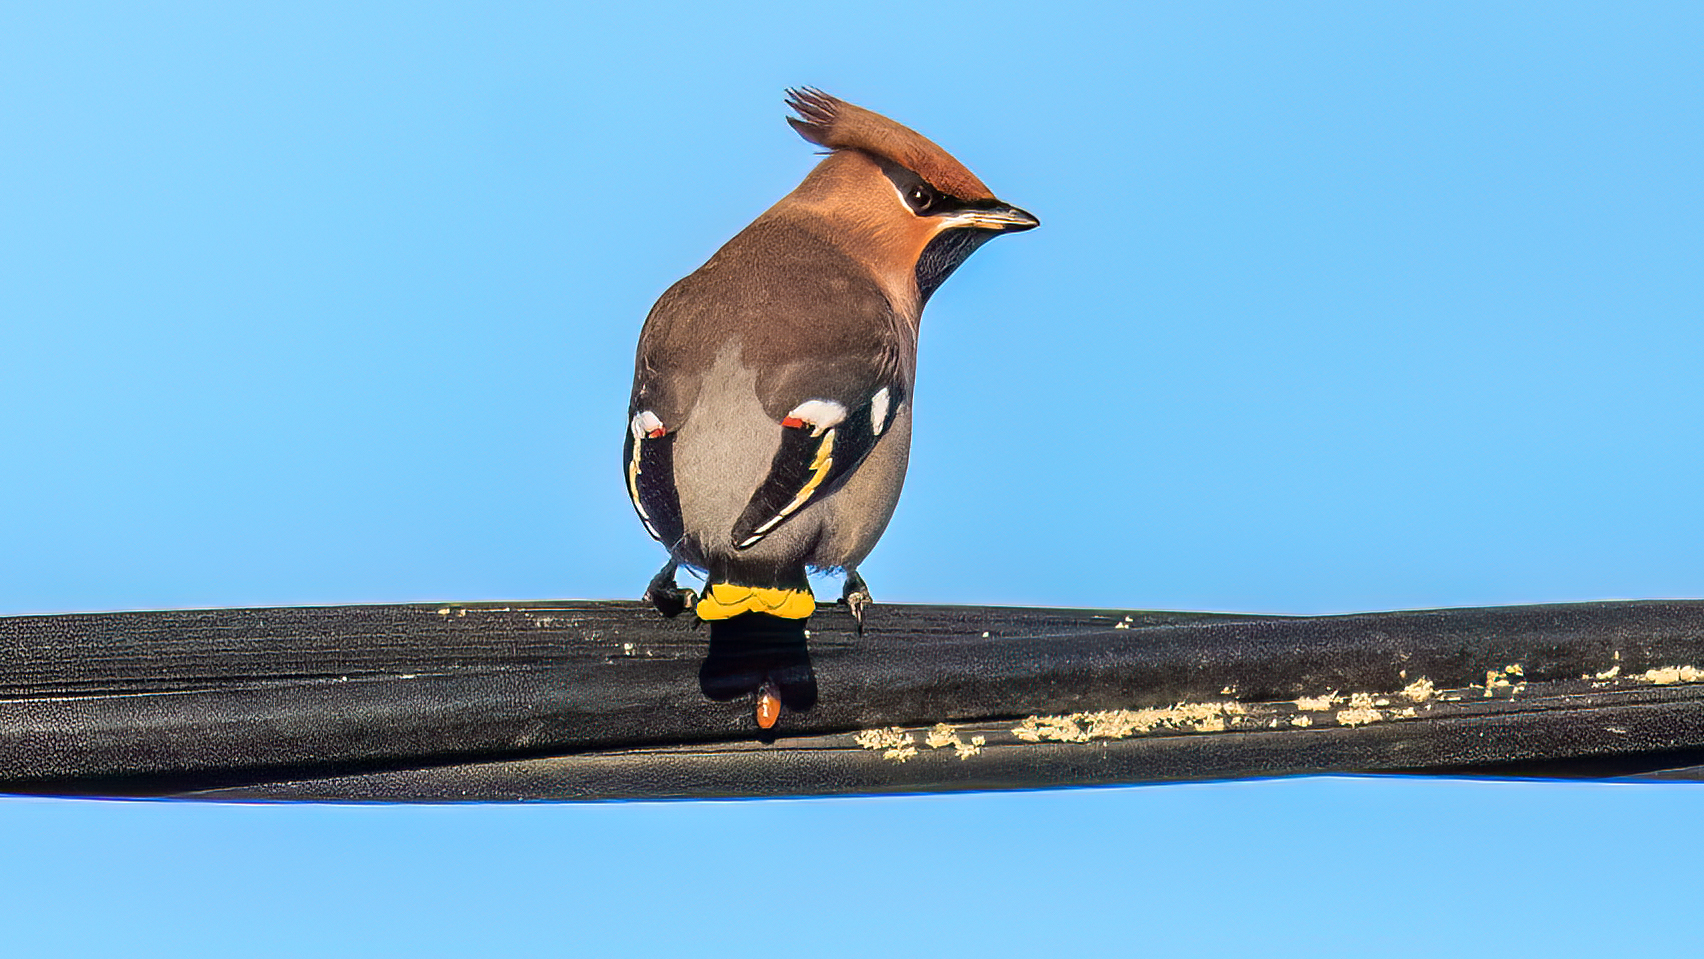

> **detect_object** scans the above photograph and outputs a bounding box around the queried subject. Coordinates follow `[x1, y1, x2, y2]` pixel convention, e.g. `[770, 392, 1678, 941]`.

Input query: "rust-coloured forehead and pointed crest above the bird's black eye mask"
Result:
[787, 87, 993, 199]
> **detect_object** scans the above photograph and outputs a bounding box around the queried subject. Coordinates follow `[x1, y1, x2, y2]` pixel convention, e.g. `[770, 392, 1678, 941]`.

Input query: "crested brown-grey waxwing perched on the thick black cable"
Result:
[622, 87, 1039, 671]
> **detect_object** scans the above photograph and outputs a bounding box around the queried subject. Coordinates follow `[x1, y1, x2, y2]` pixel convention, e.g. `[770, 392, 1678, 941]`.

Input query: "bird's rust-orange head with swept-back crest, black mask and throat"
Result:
[787, 87, 1039, 310]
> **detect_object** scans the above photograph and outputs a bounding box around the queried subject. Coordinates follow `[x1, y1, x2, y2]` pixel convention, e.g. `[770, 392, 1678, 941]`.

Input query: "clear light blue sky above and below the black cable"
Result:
[0, 3, 1704, 956]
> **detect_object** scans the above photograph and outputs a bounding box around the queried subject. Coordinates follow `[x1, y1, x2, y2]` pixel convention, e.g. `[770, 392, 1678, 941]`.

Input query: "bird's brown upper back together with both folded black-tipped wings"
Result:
[625, 220, 917, 548]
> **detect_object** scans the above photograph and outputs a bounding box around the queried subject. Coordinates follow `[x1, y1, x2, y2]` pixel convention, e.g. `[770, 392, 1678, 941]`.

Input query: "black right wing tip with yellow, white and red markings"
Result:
[733, 382, 905, 550]
